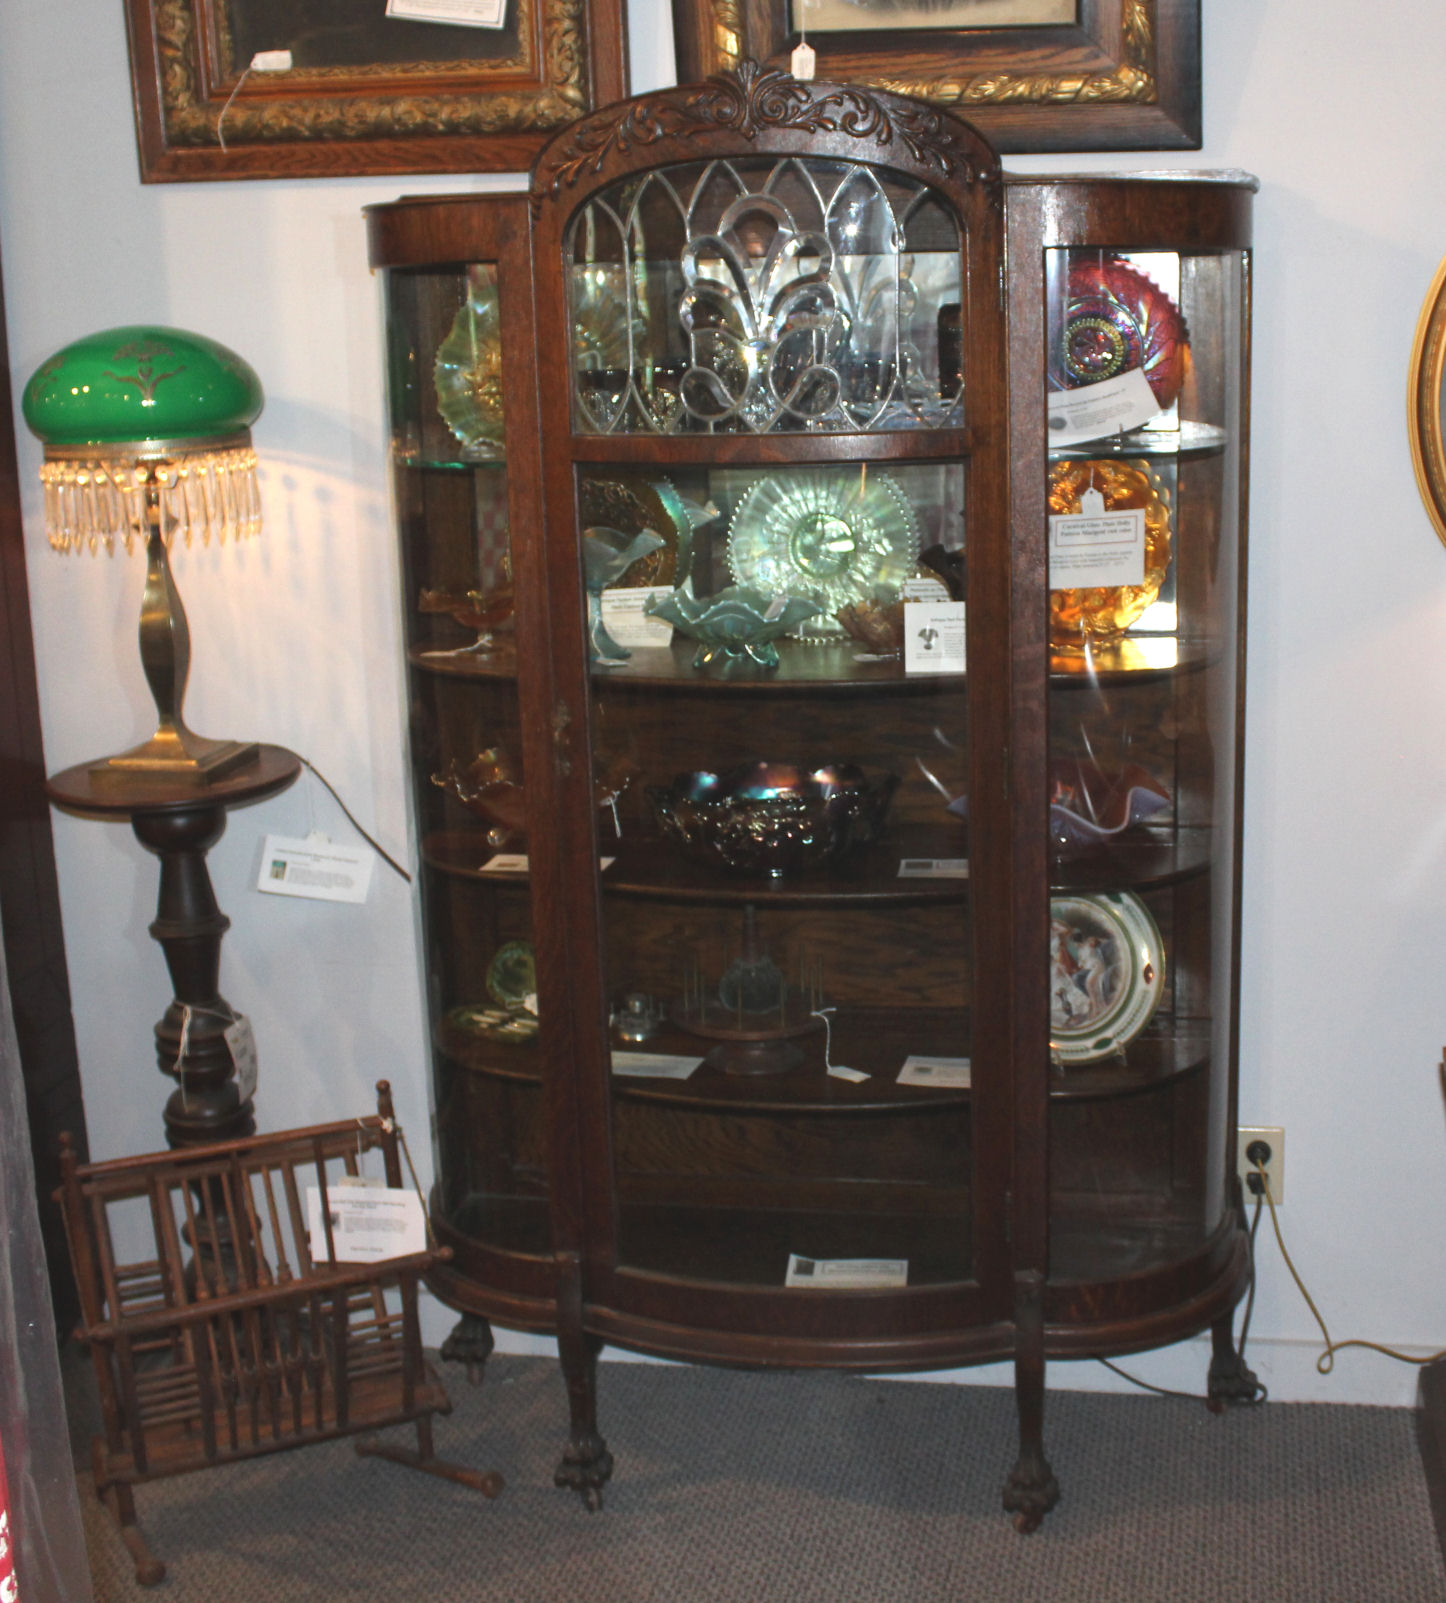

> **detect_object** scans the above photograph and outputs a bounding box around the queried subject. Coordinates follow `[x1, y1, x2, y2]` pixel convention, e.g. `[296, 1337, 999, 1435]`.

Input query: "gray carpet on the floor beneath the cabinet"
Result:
[82, 1358, 1446, 1603]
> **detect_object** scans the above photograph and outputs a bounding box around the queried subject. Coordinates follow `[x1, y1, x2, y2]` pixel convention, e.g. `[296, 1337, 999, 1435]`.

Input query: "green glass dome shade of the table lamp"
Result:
[21, 324, 263, 447]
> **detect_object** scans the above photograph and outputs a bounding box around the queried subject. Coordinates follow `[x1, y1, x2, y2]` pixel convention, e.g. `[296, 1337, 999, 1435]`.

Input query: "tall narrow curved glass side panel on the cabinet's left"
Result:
[386, 263, 550, 1252]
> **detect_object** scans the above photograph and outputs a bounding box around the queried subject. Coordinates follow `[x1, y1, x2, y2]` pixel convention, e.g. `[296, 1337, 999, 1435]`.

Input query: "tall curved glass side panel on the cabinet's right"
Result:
[1045, 248, 1242, 1281]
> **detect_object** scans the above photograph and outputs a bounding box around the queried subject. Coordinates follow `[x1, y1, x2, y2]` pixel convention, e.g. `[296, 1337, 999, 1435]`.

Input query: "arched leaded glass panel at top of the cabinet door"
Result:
[566, 157, 963, 434]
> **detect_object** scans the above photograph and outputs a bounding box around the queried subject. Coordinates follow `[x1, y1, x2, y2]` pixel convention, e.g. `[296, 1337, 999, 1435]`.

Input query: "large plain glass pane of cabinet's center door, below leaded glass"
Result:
[579, 462, 973, 1289]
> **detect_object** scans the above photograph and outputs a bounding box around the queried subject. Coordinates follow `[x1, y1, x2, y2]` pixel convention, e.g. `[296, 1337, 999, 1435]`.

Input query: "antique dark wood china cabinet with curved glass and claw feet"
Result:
[369, 67, 1254, 1529]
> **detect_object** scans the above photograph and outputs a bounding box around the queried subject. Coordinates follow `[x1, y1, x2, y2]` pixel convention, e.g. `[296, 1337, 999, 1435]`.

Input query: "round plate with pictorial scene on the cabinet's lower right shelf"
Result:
[1050, 891, 1165, 1063]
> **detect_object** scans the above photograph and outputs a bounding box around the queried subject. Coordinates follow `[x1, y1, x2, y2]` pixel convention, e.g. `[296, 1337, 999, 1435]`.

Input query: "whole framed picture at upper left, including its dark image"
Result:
[118, 0, 627, 183]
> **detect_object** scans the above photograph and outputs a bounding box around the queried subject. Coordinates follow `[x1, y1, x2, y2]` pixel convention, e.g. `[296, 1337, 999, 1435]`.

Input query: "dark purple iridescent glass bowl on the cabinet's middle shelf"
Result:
[648, 763, 899, 878]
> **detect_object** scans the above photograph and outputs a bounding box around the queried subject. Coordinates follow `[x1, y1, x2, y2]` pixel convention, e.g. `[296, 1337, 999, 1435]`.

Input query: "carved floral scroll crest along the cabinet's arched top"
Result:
[534, 61, 1000, 196]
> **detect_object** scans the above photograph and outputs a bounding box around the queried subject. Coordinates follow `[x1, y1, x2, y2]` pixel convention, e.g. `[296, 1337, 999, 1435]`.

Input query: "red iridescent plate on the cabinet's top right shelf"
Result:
[1050, 255, 1190, 410]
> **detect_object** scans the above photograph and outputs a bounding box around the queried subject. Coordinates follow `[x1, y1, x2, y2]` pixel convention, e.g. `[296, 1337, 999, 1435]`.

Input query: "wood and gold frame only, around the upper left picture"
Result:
[127, 0, 627, 183]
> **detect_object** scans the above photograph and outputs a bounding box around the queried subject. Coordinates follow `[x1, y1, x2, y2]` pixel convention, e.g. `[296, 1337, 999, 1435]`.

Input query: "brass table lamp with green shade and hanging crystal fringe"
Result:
[22, 325, 263, 789]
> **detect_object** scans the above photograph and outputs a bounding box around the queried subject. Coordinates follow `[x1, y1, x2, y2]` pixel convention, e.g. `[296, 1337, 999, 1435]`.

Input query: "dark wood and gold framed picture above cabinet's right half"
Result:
[673, 0, 1201, 152]
